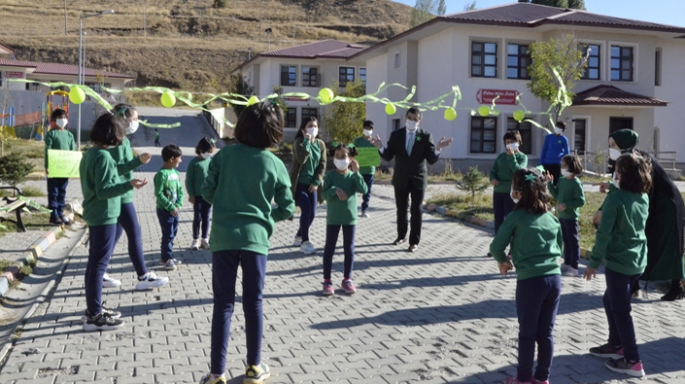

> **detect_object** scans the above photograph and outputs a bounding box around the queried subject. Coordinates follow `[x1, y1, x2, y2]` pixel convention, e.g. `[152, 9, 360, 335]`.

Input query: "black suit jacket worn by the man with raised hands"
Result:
[381, 127, 439, 189]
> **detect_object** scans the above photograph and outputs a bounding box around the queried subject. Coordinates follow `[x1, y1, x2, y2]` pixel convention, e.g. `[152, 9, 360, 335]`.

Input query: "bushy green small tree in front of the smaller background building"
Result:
[323, 79, 366, 144]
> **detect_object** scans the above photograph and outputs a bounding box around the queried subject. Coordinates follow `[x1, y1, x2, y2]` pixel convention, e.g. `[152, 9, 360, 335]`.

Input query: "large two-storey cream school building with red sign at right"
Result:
[352, 3, 685, 171]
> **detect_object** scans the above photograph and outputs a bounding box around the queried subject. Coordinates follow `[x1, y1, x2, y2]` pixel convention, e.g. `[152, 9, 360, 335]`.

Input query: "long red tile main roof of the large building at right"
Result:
[438, 3, 685, 34]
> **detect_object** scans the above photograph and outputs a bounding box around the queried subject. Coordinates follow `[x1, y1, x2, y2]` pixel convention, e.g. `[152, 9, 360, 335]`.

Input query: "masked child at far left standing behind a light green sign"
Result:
[45, 108, 76, 225]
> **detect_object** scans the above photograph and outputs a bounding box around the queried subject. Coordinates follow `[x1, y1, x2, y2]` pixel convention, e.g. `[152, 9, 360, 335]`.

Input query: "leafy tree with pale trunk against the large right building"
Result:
[527, 35, 589, 128]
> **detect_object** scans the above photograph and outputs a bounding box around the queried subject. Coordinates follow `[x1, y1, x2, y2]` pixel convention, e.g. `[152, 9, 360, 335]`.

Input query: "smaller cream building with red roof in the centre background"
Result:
[234, 40, 366, 141]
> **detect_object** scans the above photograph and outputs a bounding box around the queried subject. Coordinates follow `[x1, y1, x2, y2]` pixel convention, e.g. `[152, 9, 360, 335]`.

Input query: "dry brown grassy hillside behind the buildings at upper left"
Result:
[0, 0, 411, 92]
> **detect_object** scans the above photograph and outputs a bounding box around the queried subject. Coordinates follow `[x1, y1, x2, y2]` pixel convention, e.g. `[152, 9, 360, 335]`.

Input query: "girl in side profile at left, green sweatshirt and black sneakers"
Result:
[79, 112, 147, 331]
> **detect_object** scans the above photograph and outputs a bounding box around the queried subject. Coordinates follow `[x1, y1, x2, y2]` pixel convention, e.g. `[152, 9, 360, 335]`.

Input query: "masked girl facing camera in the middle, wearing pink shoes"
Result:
[322, 144, 368, 296]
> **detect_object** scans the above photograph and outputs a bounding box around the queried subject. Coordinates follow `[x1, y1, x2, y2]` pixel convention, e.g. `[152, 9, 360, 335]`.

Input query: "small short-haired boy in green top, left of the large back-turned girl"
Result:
[155, 144, 183, 271]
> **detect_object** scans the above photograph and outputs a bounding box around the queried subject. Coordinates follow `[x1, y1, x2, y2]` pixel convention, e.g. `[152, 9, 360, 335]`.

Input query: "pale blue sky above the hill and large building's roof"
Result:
[394, 0, 685, 27]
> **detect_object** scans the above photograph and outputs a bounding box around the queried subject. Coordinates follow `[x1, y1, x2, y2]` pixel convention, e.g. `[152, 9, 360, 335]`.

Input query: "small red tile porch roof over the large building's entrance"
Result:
[573, 85, 668, 107]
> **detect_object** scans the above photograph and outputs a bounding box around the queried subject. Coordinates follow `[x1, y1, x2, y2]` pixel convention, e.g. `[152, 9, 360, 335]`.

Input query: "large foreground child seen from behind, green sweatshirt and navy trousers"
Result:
[200, 101, 295, 384]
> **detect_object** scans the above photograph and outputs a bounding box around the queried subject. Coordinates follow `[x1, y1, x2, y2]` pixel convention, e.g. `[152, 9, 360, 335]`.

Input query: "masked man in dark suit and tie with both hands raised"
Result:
[373, 108, 452, 252]
